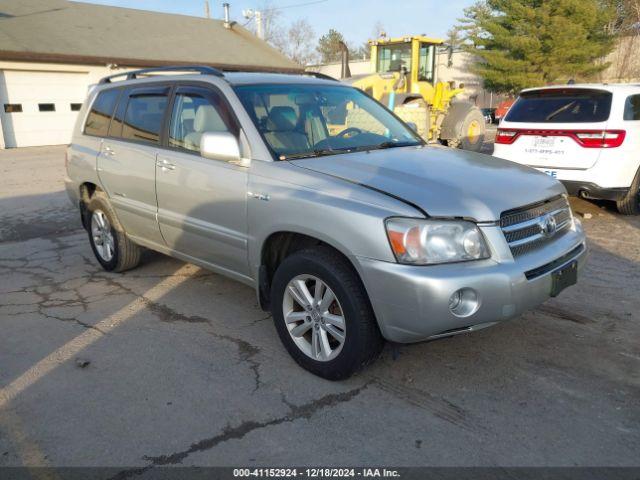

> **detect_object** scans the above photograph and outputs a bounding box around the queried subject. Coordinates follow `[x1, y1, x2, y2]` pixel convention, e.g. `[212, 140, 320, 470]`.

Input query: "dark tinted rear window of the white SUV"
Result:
[505, 88, 612, 123]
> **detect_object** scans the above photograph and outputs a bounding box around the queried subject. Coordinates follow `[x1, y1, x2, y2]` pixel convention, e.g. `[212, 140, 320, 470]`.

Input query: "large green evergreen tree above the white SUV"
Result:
[460, 0, 615, 93]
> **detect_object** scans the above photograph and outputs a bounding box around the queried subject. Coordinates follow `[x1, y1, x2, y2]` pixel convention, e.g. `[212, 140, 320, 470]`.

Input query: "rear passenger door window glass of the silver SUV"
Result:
[121, 87, 169, 144]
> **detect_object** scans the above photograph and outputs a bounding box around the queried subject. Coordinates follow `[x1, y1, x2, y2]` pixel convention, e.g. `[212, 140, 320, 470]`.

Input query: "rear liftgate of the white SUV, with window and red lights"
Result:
[495, 88, 624, 169]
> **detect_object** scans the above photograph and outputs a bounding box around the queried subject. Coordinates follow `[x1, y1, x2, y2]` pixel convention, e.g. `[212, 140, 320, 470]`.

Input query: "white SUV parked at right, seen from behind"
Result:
[493, 84, 640, 215]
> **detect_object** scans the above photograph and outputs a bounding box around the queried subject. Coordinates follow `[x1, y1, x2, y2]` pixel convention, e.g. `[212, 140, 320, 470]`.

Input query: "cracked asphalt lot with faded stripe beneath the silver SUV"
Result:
[0, 147, 640, 470]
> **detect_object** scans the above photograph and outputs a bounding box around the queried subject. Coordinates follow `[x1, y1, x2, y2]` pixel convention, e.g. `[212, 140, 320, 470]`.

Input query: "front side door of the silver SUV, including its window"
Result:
[156, 86, 249, 276]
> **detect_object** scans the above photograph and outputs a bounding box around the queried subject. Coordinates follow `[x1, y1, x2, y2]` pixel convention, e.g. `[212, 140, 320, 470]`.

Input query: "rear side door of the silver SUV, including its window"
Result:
[98, 85, 170, 245]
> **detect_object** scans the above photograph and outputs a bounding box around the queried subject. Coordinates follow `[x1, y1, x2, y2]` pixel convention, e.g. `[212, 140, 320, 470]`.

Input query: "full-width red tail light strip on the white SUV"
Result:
[495, 128, 627, 148]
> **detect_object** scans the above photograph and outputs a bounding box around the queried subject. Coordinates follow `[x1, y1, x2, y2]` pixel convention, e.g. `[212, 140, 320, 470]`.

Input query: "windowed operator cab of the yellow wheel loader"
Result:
[371, 36, 442, 91]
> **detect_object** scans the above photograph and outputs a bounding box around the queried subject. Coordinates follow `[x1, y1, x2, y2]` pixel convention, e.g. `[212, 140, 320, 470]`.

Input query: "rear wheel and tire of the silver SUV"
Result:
[87, 192, 141, 272]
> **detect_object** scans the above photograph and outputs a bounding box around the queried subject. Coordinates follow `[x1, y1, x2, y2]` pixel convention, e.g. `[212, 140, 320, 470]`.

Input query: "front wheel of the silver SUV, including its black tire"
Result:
[271, 247, 384, 380]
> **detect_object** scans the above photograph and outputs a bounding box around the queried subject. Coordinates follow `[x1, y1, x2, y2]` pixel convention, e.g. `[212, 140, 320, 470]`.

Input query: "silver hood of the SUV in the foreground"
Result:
[291, 147, 565, 222]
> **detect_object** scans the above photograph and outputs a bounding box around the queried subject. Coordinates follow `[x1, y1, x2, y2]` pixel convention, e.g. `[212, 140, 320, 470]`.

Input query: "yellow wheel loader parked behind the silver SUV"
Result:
[343, 35, 485, 151]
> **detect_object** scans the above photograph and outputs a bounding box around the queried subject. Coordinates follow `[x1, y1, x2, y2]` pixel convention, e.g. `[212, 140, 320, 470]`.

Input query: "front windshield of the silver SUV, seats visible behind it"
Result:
[235, 85, 423, 160]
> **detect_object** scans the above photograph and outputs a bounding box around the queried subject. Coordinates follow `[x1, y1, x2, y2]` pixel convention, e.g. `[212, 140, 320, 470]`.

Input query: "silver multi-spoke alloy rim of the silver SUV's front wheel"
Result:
[282, 275, 347, 362]
